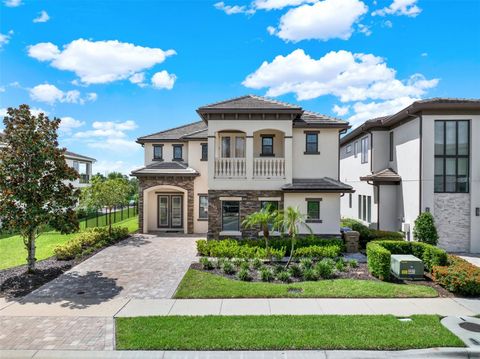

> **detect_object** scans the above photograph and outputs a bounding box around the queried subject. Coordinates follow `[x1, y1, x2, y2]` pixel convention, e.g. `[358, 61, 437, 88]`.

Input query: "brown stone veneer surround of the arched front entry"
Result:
[138, 176, 195, 233]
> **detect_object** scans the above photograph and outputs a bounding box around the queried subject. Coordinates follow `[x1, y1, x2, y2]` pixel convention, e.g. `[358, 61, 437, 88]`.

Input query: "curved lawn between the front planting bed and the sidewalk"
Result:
[175, 269, 438, 298]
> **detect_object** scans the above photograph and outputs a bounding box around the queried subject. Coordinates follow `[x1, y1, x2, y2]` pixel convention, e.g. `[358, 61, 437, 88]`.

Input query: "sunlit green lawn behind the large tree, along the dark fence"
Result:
[0, 217, 138, 270]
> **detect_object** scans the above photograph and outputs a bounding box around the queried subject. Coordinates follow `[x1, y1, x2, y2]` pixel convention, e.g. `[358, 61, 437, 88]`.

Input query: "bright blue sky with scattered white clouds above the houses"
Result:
[0, 0, 480, 172]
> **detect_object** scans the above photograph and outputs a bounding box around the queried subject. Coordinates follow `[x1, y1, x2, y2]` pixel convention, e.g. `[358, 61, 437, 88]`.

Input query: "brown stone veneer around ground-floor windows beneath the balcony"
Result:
[208, 190, 283, 238]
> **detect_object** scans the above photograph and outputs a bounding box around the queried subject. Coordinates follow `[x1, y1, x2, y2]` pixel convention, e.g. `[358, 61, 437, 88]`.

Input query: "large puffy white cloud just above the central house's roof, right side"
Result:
[243, 49, 438, 102]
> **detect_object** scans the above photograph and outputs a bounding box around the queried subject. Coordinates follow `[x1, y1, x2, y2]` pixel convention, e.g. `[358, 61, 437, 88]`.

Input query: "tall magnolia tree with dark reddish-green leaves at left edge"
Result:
[0, 105, 79, 272]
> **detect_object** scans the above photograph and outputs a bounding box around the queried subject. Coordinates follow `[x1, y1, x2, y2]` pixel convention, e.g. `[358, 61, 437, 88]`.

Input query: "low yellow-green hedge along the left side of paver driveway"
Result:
[54, 227, 129, 260]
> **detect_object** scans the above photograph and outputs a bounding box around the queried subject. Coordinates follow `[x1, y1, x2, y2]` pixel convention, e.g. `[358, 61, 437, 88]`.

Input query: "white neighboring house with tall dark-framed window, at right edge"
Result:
[340, 98, 480, 253]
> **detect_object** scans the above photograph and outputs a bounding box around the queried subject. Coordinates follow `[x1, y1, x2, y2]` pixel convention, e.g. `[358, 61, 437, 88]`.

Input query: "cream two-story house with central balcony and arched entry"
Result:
[132, 95, 352, 238]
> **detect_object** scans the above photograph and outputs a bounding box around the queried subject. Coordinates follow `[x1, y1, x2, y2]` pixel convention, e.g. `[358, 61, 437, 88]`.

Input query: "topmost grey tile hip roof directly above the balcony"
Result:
[198, 95, 302, 112]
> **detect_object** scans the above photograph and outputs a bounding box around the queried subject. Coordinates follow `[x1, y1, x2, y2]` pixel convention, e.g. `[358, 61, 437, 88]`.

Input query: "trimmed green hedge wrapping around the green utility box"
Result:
[367, 241, 447, 280]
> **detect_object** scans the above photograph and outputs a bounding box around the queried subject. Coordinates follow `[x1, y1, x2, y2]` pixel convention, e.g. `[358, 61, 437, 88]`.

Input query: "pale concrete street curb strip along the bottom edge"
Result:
[0, 348, 480, 359]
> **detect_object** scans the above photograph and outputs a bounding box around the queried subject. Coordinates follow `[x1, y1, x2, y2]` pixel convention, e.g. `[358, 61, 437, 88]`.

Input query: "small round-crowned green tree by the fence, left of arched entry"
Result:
[81, 176, 131, 234]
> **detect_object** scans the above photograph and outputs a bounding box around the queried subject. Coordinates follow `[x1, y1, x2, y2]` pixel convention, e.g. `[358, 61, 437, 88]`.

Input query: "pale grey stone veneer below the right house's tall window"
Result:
[433, 193, 471, 252]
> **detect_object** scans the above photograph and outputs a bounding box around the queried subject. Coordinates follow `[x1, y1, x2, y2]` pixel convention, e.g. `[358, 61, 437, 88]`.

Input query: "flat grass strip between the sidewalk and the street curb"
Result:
[116, 315, 464, 350]
